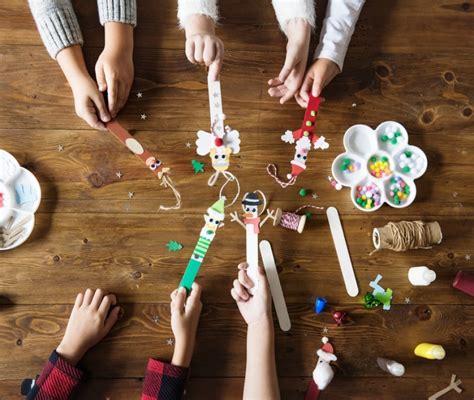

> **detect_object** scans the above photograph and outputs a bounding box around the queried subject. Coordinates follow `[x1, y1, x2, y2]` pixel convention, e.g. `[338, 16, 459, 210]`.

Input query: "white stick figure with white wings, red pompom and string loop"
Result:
[196, 76, 240, 207]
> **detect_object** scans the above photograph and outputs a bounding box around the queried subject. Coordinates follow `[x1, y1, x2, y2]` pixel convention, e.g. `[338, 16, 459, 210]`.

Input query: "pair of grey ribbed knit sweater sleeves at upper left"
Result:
[28, 0, 137, 58]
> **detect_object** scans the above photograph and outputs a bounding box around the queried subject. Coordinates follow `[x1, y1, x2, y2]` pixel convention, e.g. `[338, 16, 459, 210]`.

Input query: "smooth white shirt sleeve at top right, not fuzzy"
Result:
[314, 0, 365, 71]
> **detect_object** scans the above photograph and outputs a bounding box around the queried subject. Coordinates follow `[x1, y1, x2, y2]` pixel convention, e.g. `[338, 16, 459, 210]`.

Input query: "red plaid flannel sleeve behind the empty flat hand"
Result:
[27, 351, 83, 400]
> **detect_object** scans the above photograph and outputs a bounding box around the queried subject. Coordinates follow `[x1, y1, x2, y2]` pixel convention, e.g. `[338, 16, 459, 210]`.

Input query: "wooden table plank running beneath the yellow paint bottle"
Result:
[0, 304, 474, 382]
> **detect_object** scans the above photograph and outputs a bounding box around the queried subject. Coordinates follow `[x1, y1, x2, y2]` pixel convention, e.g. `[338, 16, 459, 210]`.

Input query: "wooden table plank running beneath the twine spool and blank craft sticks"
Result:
[0, 214, 474, 307]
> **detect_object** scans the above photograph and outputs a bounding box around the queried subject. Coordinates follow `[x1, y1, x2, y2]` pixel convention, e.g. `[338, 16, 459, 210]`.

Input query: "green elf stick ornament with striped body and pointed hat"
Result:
[179, 197, 225, 291]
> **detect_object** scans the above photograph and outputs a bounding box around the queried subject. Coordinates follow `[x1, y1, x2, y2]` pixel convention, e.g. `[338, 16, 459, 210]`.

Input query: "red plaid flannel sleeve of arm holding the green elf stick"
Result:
[142, 358, 189, 400]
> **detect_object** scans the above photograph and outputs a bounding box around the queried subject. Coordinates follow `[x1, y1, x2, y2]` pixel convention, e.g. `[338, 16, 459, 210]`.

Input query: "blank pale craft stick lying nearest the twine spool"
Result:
[326, 207, 359, 297]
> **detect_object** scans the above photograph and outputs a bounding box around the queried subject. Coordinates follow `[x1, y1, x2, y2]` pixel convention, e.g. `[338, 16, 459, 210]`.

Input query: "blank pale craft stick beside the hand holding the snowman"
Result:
[260, 240, 291, 332]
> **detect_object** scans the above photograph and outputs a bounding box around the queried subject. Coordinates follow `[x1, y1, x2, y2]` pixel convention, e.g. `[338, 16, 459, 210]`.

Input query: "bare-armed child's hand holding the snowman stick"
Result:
[230, 263, 272, 325]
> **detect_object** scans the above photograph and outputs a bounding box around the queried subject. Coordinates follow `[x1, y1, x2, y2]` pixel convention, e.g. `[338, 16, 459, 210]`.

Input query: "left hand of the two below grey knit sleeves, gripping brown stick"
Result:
[71, 75, 110, 131]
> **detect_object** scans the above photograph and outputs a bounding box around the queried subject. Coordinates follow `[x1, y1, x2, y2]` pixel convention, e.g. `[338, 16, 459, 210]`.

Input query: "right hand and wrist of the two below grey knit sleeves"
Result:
[95, 22, 133, 118]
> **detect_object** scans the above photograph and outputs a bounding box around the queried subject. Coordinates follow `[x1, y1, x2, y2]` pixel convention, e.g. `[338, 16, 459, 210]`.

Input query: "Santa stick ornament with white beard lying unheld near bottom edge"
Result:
[305, 336, 337, 400]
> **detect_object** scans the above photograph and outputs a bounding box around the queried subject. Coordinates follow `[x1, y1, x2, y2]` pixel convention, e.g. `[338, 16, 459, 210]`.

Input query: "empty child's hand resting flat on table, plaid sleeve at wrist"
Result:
[56, 289, 120, 365]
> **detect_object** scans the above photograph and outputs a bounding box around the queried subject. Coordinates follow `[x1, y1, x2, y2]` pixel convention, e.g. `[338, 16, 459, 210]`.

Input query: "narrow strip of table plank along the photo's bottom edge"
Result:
[0, 374, 474, 400]
